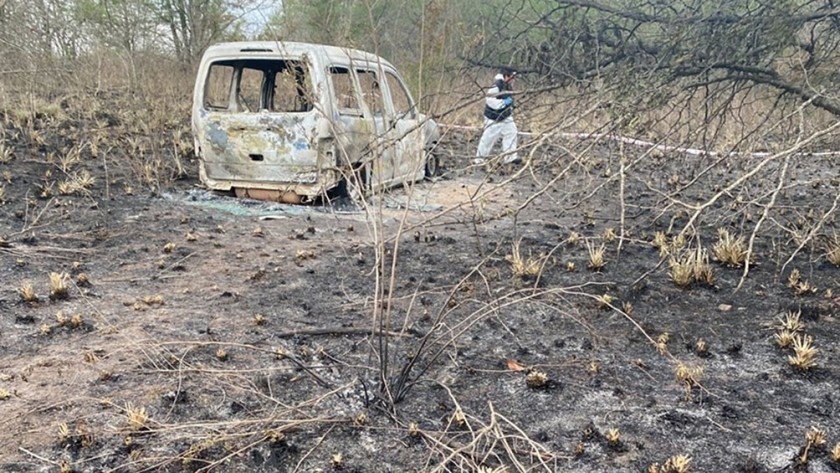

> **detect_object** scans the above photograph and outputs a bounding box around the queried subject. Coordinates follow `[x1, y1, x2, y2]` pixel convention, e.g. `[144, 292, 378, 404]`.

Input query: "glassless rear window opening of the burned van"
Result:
[204, 59, 313, 113]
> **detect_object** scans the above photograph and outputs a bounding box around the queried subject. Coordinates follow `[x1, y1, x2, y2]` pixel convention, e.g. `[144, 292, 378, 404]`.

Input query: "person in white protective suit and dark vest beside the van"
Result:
[473, 67, 522, 164]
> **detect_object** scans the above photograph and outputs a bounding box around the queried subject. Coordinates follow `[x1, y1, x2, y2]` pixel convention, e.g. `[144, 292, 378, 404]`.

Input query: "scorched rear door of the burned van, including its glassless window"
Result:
[198, 58, 323, 188]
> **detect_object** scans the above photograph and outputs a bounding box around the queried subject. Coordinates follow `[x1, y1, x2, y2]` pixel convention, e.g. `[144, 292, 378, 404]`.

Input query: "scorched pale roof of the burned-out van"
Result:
[204, 41, 394, 68]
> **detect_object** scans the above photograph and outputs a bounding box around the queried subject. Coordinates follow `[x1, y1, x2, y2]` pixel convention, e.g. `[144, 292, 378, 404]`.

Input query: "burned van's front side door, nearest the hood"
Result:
[384, 70, 425, 183]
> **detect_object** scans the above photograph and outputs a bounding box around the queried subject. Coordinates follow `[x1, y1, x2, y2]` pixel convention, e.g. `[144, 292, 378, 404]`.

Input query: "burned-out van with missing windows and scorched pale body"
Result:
[192, 42, 439, 202]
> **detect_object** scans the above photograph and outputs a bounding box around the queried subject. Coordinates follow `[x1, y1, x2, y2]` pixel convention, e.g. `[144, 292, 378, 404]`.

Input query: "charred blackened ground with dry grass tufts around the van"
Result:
[0, 108, 840, 472]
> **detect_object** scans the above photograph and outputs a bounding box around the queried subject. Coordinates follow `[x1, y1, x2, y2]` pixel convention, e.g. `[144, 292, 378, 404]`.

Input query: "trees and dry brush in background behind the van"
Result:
[0, 0, 840, 142]
